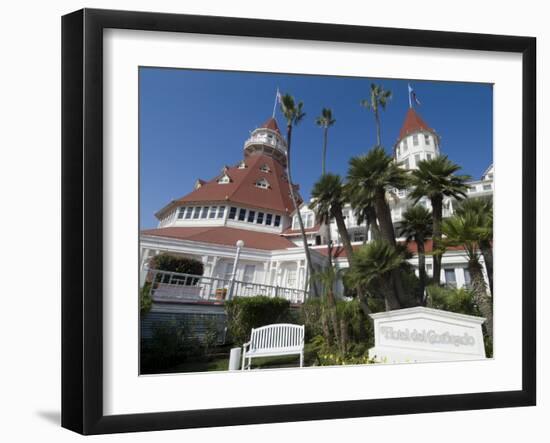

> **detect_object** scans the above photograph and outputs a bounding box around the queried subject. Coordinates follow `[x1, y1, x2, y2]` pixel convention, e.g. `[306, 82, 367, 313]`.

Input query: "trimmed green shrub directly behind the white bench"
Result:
[225, 295, 291, 346]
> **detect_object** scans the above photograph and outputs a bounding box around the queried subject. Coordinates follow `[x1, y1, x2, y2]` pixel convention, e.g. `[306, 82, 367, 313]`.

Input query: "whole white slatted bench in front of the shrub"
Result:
[241, 323, 304, 370]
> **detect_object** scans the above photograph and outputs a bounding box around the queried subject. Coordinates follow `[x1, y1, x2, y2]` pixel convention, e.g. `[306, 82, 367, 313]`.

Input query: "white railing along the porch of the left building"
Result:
[146, 270, 306, 303]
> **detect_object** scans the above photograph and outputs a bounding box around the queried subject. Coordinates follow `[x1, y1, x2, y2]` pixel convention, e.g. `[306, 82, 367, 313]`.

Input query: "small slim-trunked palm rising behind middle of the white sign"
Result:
[400, 205, 432, 304]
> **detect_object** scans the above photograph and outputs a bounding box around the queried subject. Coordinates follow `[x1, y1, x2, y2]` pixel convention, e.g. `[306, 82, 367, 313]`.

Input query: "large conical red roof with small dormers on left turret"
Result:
[165, 153, 302, 217]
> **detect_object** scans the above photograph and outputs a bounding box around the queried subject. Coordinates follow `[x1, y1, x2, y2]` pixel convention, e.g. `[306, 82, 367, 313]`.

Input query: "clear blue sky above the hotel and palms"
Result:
[139, 67, 493, 228]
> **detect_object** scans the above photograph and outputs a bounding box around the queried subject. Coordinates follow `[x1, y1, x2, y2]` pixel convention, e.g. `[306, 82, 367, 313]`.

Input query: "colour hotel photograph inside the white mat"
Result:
[136, 66, 495, 375]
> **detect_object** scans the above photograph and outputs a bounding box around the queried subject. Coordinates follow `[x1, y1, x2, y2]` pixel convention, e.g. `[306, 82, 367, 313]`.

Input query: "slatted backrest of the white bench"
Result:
[250, 323, 304, 349]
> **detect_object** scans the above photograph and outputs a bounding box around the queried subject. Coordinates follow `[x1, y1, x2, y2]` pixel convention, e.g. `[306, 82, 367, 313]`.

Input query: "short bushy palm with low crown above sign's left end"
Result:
[345, 240, 405, 311]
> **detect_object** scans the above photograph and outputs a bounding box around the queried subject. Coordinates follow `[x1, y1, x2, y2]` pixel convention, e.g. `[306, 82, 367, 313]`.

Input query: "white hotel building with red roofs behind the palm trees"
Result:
[140, 108, 493, 303]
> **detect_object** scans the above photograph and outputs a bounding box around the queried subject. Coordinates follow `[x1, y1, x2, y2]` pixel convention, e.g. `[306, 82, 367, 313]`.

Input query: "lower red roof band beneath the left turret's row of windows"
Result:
[141, 226, 296, 251]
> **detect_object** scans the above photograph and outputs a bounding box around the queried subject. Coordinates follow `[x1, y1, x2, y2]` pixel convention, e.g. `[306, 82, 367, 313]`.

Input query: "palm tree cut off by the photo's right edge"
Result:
[456, 197, 493, 294]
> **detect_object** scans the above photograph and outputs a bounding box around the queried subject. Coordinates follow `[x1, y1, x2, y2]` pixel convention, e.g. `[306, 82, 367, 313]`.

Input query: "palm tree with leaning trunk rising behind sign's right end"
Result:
[442, 211, 493, 339]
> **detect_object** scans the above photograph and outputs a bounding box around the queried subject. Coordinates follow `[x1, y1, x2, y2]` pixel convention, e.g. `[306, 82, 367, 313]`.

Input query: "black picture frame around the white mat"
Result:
[62, 9, 537, 434]
